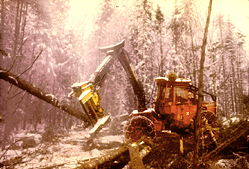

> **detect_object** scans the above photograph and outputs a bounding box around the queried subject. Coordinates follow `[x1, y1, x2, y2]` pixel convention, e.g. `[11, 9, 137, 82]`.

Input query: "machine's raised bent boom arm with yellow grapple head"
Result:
[69, 40, 146, 133]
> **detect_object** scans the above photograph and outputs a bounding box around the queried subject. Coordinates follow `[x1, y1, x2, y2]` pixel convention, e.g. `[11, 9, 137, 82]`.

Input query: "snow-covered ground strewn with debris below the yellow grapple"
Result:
[0, 126, 123, 169]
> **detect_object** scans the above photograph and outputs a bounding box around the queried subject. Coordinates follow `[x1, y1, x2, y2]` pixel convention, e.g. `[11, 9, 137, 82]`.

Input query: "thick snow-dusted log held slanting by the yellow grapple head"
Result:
[0, 67, 88, 122]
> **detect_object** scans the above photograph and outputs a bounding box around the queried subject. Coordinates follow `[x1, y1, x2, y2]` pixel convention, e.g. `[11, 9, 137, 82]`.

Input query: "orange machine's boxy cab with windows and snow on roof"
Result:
[155, 77, 197, 130]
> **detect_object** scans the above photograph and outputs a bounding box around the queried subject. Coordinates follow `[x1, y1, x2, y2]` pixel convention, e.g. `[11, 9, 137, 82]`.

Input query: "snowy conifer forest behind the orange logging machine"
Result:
[0, 0, 249, 151]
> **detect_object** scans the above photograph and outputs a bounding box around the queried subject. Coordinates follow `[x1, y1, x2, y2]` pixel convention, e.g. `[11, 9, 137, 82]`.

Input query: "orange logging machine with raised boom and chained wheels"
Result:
[69, 40, 219, 152]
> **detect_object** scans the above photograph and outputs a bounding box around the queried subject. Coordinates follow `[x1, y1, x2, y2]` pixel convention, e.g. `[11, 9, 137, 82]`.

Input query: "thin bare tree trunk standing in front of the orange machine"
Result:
[193, 0, 212, 168]
